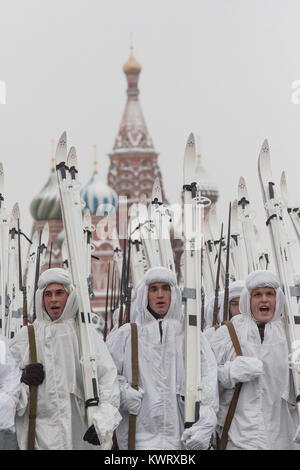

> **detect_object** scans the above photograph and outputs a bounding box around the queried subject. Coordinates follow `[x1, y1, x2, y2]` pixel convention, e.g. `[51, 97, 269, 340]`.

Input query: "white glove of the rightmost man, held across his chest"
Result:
[230, 356, 263, 385]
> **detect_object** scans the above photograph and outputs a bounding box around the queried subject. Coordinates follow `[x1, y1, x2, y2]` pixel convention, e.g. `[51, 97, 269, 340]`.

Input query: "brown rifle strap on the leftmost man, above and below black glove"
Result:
[27, 325, 37, 450]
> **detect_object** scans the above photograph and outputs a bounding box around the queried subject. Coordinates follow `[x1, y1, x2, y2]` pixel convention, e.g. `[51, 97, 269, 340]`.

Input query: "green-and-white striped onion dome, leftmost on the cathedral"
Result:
[30, 155, 61, 220]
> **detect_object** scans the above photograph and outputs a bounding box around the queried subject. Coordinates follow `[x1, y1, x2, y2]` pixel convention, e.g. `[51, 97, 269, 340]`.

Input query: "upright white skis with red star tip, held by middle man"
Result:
[182, 133, 203, 428]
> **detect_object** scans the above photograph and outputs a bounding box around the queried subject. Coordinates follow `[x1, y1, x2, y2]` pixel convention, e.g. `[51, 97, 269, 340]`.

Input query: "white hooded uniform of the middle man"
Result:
[107, 267, 218, 450]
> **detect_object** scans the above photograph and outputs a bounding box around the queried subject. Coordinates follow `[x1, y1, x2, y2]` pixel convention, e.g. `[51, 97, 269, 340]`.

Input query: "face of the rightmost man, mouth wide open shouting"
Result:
[250, 287, 276, 323]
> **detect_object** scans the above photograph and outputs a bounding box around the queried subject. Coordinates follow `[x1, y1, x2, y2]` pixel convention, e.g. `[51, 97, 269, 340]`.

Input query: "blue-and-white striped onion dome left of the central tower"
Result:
[81, 171, 118, 215]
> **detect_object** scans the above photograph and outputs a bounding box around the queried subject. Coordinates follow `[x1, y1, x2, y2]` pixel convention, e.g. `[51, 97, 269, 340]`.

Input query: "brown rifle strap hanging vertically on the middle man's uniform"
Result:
[128, 323, 139, 450]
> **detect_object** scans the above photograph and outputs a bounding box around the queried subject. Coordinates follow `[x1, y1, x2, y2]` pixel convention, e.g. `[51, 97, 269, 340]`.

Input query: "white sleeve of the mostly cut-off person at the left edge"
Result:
[0, 338, 21, 429]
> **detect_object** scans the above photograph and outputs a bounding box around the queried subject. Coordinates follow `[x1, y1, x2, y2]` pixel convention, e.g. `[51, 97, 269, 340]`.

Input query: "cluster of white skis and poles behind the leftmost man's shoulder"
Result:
[0, 163, 49, 339]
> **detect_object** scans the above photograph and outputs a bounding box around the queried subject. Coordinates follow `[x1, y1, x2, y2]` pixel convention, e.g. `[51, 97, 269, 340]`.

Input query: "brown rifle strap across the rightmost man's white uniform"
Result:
[218, 321, 243, 450]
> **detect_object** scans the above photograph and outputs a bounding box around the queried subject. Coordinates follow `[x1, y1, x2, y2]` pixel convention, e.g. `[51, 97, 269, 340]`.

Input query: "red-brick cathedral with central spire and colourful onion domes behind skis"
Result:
[30, 46, 218, 314]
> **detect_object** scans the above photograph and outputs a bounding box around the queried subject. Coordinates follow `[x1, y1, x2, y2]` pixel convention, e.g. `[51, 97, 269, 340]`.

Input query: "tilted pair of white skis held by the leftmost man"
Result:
[55, 132, 100, 434]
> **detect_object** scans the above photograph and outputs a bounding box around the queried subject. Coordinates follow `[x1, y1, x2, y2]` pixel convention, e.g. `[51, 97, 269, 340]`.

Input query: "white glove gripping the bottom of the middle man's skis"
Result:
[181, 405, 217, 450]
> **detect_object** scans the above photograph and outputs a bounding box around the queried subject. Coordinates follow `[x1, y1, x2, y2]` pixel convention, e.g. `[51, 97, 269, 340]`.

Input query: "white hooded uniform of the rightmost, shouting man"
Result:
[210, 271, 300, 450]
